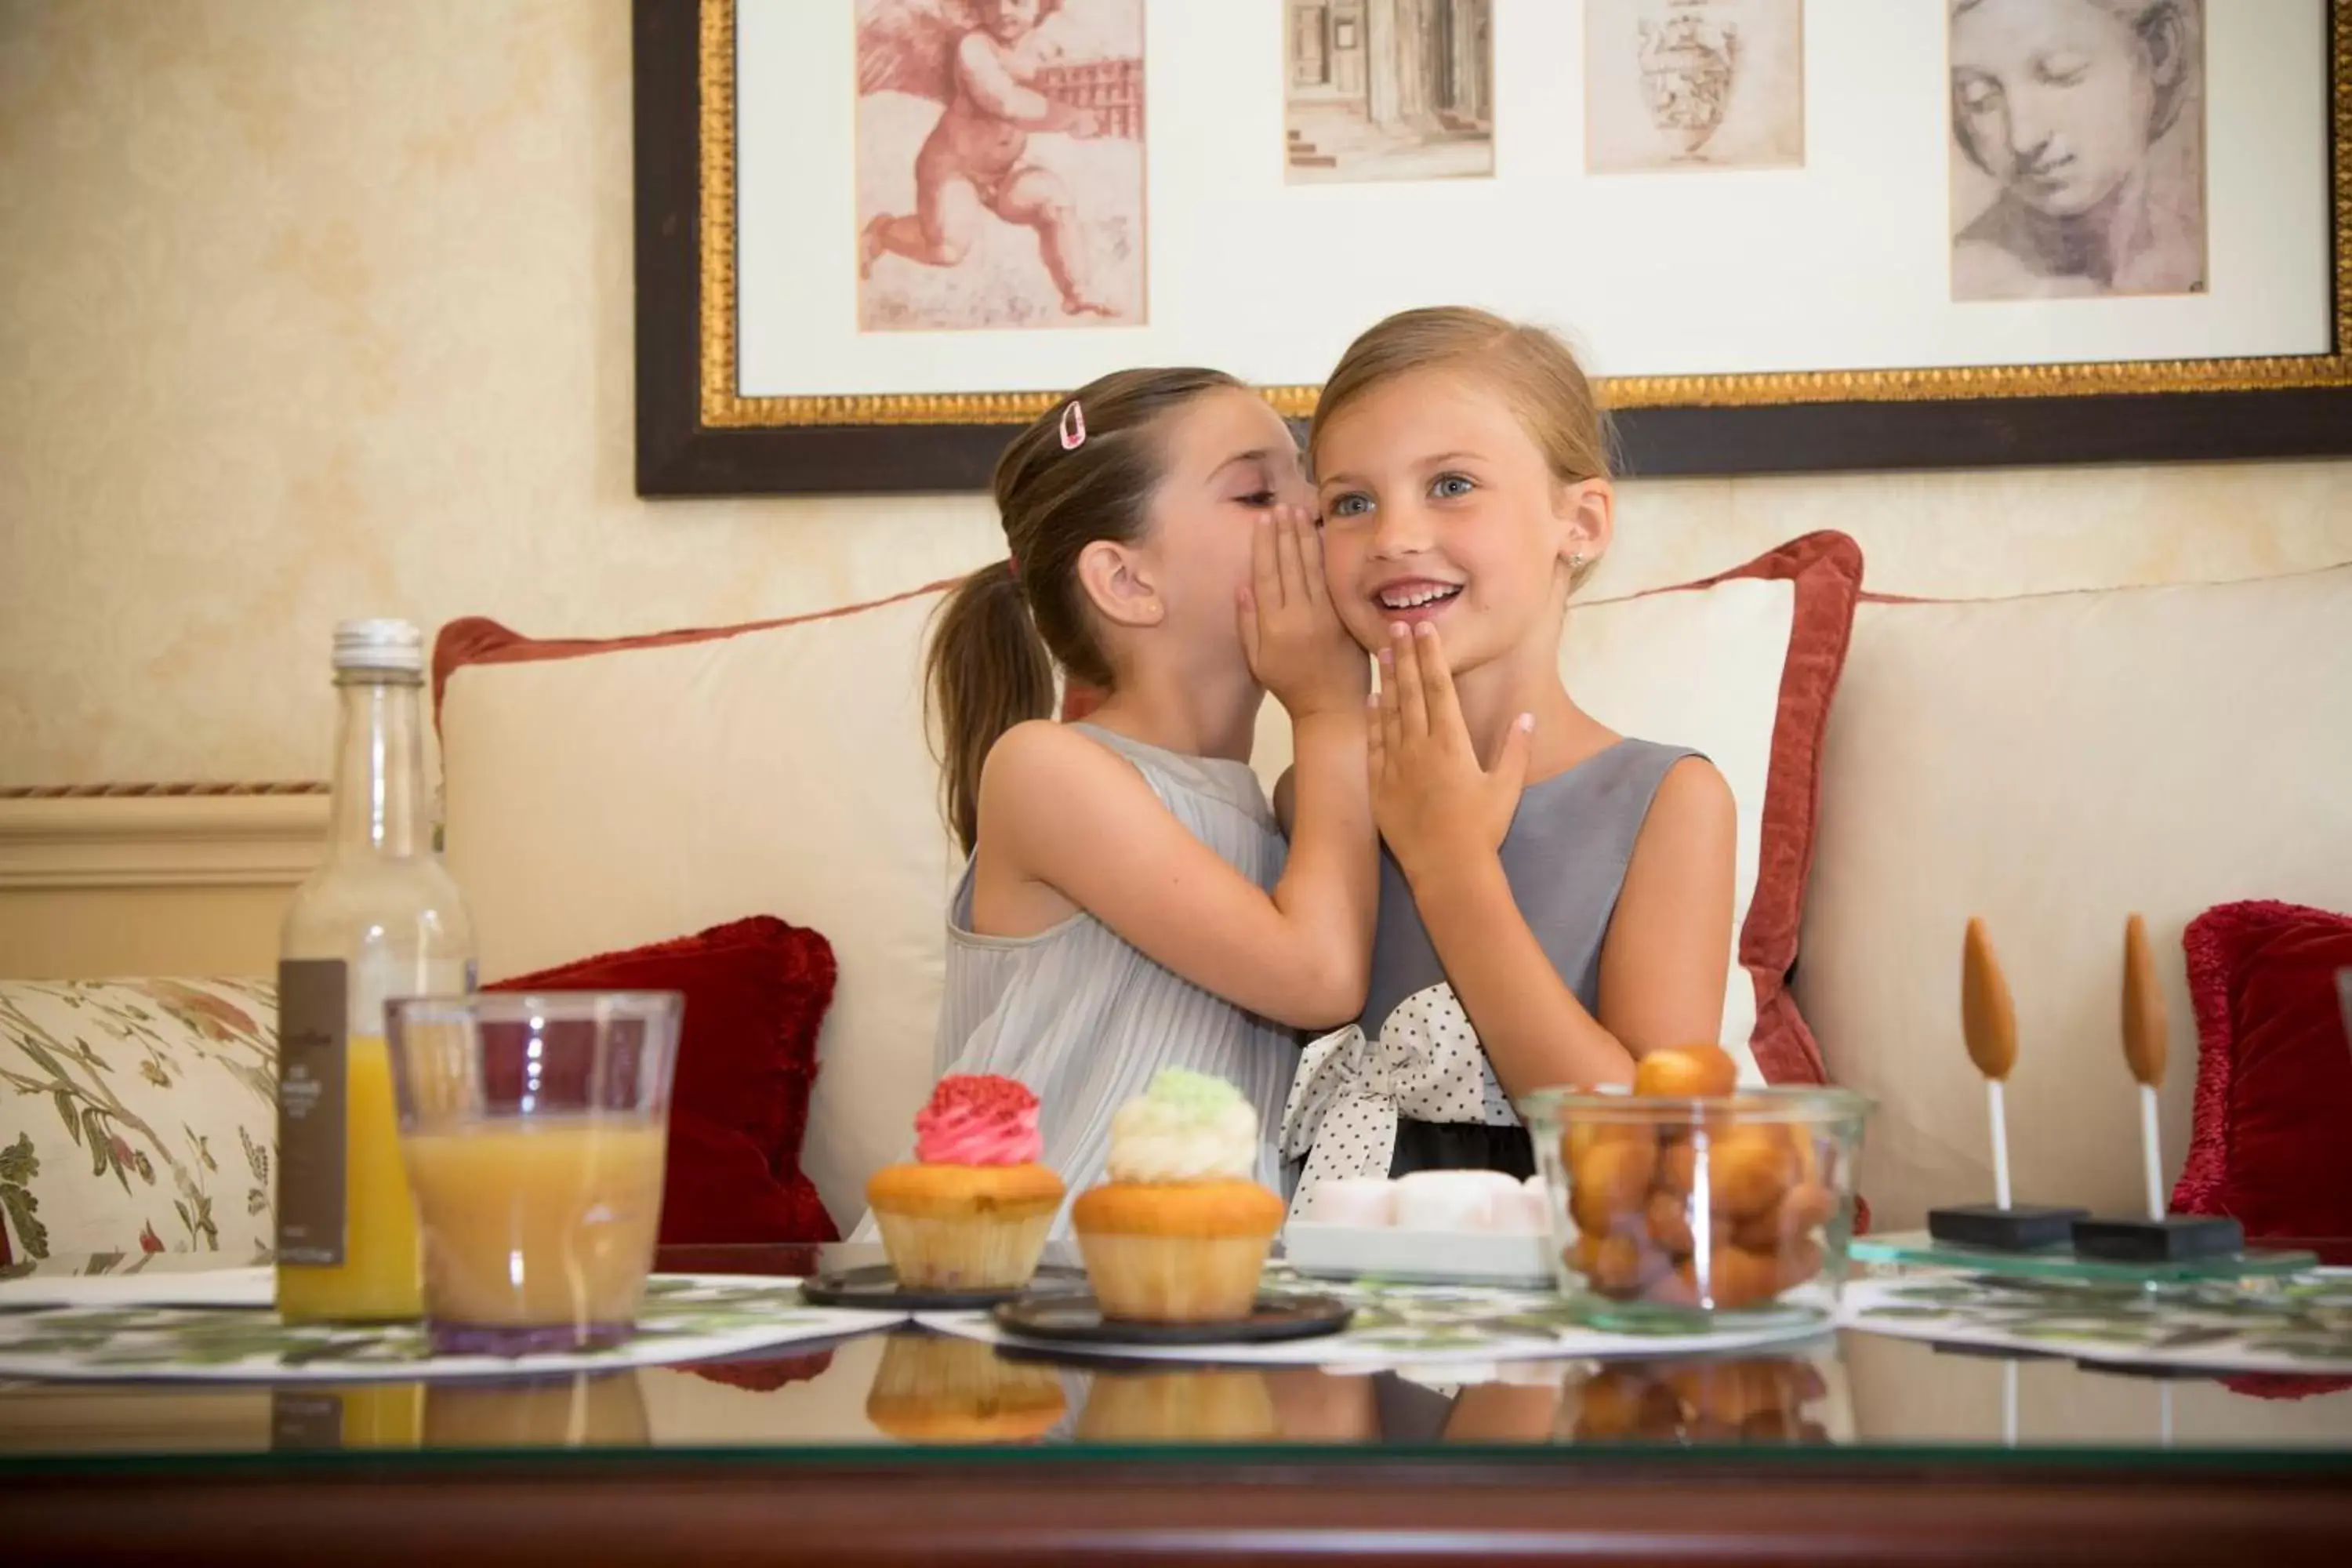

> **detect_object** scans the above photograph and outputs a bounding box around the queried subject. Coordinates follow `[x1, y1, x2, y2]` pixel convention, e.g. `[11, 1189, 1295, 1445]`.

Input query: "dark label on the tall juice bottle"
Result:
[278, 959, 350, 1267]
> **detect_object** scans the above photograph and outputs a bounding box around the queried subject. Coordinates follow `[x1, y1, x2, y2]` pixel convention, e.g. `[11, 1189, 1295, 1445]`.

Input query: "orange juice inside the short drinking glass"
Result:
[402, 1116, 666, 1342]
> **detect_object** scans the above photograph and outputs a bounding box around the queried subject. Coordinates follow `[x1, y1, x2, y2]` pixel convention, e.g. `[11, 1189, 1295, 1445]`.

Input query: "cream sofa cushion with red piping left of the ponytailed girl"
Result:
[435, 590, 960, 1232]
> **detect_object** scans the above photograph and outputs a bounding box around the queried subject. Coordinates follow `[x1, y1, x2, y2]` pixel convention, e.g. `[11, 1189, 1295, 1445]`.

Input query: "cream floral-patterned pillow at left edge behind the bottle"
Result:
[0, 980, 278, 1274]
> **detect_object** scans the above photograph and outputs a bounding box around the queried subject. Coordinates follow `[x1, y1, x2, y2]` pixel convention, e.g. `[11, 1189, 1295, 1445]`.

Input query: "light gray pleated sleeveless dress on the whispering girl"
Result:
[913, 724, 1298, 1236]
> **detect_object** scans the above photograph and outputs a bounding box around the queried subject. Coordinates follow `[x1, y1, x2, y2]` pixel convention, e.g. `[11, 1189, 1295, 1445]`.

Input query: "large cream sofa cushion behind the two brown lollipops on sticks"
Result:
[1797, 567, 2352, 1229]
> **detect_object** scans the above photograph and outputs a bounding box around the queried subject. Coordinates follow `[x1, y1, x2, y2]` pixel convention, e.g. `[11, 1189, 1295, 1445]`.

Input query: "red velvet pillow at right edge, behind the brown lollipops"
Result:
[2173, 902, 2352, 1236]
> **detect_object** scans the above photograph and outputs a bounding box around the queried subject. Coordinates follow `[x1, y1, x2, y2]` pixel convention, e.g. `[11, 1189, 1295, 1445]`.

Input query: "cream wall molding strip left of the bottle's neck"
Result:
[0, 794, 327, 891]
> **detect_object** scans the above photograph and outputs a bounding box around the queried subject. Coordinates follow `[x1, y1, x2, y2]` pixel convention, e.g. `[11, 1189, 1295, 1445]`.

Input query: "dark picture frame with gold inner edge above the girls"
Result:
[635, 0, 2352, 494]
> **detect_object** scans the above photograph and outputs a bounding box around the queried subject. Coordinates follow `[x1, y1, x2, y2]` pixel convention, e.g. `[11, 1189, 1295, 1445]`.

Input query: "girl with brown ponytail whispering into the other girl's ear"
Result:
[898, 369, 1376, 1225]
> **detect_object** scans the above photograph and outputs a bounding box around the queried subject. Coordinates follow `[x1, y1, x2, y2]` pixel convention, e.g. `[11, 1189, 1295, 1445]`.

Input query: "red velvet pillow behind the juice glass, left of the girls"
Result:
[485, 914, 840, 1246]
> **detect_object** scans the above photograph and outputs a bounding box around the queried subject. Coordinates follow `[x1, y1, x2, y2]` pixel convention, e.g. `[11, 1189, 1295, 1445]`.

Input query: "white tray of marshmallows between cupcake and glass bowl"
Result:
[1282, 1171, 1552, 1286]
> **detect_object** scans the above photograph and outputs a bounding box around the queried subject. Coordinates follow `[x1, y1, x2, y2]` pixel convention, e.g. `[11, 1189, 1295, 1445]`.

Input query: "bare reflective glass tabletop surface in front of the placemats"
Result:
[0, 1246, 2352, 1476]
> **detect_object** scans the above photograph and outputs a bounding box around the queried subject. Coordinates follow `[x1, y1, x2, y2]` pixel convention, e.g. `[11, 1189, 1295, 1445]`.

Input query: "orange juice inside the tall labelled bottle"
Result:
[278, 1034, 423, 1321]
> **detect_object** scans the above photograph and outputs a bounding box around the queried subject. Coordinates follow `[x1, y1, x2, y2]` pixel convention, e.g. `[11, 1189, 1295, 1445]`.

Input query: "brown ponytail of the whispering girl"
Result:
[924, 560, 1054, 855]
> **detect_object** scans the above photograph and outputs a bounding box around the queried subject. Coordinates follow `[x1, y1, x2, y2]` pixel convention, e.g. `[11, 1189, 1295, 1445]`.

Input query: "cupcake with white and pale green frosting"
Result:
[1070, 1067, 1282, 1323]
